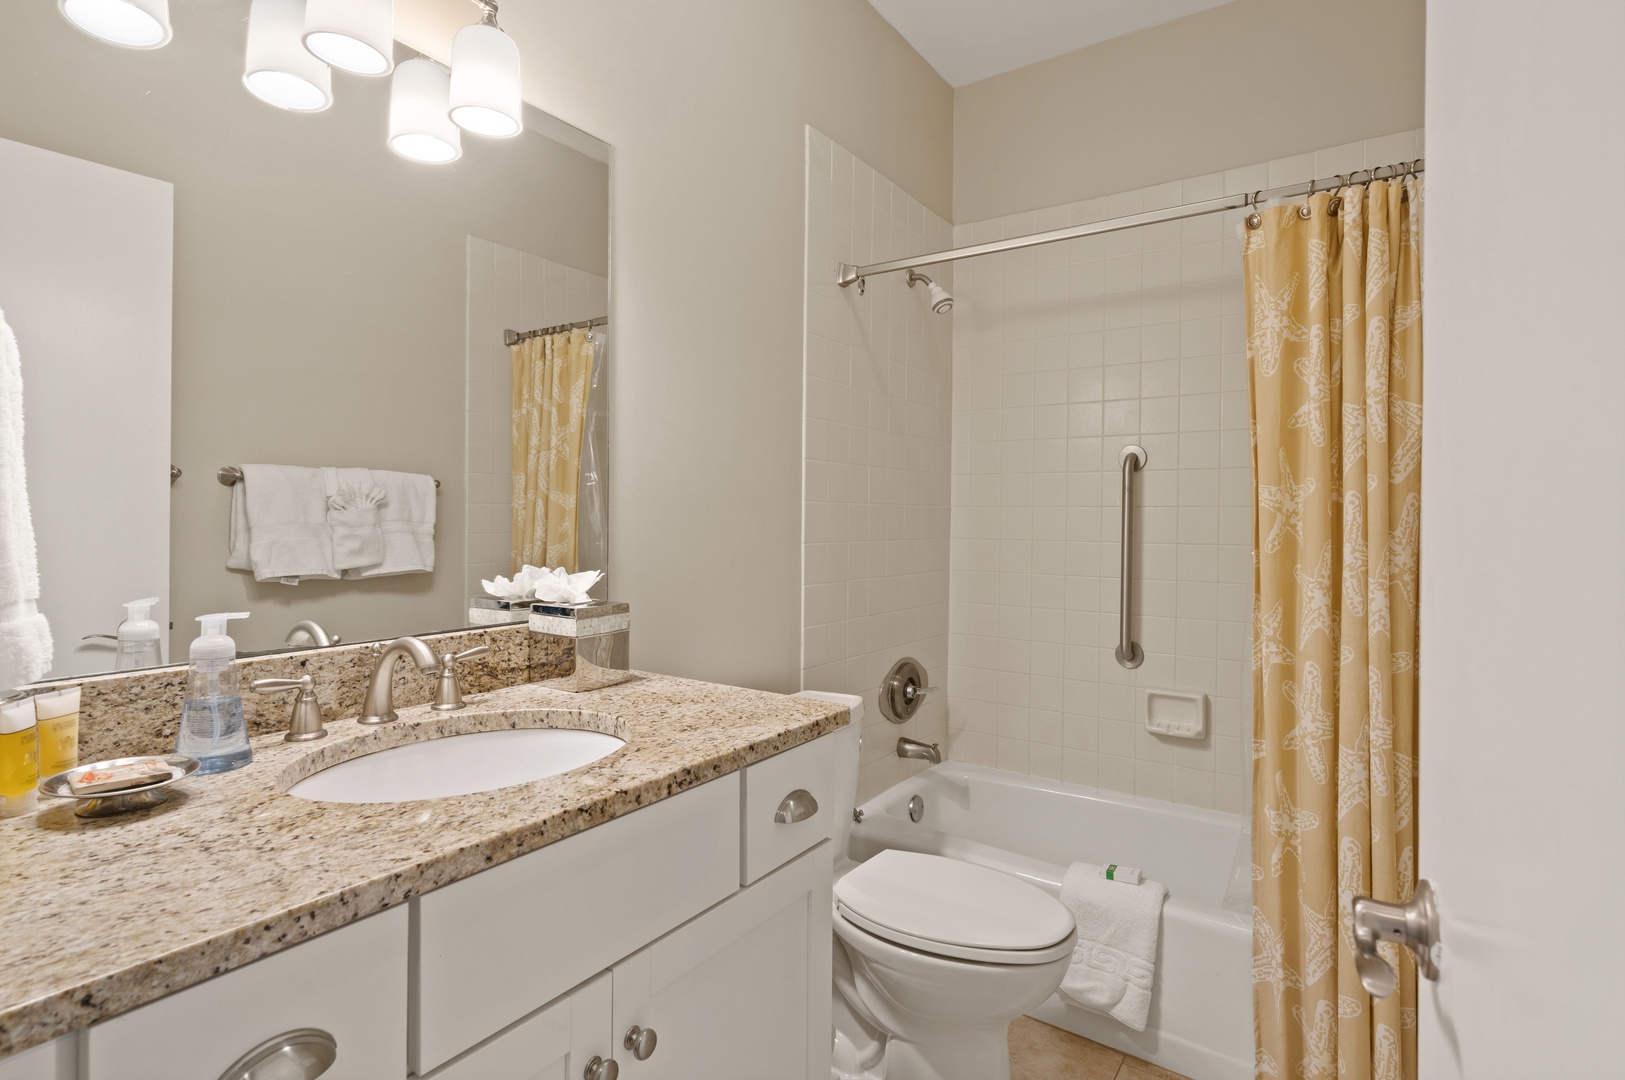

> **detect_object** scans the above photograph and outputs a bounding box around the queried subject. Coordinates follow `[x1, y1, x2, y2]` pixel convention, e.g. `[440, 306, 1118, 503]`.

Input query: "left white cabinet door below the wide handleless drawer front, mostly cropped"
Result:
[426, 971, 614, 1080]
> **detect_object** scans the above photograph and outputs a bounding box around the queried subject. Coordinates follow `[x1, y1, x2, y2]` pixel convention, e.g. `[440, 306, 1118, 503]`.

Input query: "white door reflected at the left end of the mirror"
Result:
[0, 140, 171, 675]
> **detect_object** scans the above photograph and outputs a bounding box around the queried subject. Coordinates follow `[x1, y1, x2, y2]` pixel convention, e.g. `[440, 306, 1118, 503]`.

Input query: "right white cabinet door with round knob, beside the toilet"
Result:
[614, 841, 832, 1080]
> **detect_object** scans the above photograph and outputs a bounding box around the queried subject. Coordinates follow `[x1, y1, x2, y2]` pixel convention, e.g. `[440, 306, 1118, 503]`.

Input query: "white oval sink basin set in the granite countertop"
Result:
[288, 728, 626, 802]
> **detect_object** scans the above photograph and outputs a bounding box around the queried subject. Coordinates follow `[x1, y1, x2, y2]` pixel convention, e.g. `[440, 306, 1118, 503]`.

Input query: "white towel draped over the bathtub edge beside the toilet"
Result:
[1061, 862, 1168, 1031]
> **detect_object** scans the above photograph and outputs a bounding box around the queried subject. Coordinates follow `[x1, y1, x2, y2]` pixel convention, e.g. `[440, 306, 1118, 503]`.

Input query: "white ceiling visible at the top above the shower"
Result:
[869, 0, 1230, 86]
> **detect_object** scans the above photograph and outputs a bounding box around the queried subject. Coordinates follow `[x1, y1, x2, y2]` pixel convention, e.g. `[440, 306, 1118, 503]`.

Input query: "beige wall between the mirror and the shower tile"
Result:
[398, 0, 952, 690]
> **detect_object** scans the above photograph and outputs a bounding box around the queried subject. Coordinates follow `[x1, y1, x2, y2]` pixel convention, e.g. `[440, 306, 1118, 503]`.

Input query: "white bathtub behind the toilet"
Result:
[848, 762, 1253, 1080]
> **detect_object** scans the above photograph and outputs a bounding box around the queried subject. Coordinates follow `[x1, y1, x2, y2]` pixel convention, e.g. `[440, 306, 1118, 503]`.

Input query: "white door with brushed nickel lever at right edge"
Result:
[1417, 0, 1625, 1080]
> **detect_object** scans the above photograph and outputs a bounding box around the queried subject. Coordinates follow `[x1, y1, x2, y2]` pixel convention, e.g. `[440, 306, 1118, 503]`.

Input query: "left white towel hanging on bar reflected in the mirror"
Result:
[226, 464, 338, 585]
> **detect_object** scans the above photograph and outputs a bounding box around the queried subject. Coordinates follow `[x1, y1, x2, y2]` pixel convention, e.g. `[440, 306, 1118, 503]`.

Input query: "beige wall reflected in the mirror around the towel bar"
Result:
[0, 0, 608, 649]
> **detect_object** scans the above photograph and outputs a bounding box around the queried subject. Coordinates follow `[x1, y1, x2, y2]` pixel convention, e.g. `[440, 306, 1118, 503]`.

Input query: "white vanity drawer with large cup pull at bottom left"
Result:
[83, 908, 408, 1080]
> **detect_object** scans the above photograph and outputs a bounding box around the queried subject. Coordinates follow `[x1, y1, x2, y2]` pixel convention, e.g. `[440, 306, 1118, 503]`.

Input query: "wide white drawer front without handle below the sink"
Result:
[410, 773, 739, 1075]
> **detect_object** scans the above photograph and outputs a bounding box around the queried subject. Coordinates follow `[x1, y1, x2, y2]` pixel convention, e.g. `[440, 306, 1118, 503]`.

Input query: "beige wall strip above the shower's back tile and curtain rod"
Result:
[954, 0, 1424, 221]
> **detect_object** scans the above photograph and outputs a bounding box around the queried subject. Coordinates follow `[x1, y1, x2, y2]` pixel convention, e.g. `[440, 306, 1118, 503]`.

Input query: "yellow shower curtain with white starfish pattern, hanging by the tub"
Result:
[1243, 177, 1422, 1080]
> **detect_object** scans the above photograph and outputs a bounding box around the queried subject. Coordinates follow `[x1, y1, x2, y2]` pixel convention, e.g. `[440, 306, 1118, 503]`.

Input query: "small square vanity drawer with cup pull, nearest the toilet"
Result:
[739, 736, 852, 885]
